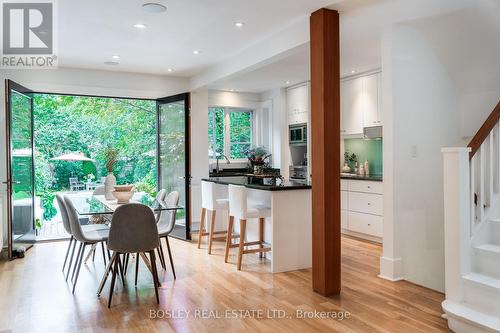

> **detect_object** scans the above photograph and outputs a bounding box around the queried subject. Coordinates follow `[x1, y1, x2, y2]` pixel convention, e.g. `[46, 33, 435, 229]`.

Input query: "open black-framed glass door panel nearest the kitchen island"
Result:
[157, 93, 191, 240]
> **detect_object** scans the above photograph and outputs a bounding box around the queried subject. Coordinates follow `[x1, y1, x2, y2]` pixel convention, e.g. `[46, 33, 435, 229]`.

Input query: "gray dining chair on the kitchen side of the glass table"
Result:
[157, 191, 179, 279]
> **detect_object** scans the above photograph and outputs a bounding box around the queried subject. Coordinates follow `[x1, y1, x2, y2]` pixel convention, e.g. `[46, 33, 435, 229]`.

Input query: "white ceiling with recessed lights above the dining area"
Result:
[57, 0, 335, 77]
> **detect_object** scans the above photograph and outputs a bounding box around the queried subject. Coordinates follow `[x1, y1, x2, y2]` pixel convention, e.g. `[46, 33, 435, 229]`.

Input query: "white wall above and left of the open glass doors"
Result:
[0, 68, 189, 248]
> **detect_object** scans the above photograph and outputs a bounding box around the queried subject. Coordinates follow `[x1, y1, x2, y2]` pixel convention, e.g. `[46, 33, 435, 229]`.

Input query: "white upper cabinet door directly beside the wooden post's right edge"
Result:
[340, 78, 363, 135]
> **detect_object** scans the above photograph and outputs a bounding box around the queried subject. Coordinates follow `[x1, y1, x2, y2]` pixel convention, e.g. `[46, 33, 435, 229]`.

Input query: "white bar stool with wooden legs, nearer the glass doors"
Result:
[198, 181, 232, 254]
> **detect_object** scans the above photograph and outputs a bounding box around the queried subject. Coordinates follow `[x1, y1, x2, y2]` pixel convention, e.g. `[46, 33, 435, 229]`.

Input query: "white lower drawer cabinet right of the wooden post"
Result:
[340, 179, 383, 241]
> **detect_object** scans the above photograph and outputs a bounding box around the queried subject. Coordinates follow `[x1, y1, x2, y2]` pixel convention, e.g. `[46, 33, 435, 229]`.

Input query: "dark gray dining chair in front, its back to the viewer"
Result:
[101, 203, 160, 308]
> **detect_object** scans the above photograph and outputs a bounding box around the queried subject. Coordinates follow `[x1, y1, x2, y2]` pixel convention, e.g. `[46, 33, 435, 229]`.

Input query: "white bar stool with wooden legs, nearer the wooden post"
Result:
[224, 185, 271, 271]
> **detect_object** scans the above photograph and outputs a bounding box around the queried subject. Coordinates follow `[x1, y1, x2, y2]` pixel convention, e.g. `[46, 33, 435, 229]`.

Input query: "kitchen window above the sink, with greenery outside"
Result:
[208, 107, 254, 160]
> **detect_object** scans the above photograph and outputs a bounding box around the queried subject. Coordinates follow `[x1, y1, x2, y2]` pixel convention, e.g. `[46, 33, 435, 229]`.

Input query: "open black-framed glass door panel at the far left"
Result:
[4, 80, 35, 258]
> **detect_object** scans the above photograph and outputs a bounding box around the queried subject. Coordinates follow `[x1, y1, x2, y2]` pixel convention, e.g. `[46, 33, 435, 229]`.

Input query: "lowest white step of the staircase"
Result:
[442, 301, 500, 332]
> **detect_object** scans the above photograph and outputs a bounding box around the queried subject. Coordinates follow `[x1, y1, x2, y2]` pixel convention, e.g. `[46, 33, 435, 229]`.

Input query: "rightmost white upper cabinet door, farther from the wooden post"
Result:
[363, 74, 382, 127]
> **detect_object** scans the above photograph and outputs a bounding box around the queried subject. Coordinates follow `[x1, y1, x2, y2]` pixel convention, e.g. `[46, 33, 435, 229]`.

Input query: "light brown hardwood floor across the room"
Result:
[0, 238, 447, 333]
